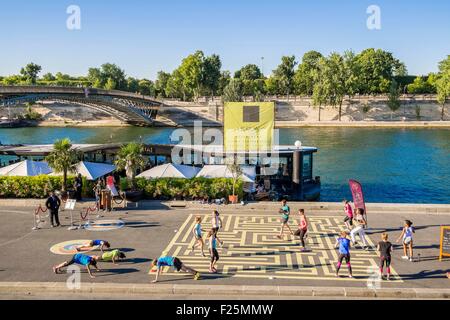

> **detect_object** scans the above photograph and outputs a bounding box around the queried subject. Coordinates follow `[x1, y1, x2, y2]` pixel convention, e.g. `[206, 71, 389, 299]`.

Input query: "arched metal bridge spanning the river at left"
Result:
[0, 86, 162, 126]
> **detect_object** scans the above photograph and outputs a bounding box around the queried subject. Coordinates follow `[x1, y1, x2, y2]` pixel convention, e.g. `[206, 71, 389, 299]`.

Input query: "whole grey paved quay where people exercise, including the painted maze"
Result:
[0, 199, 450, 299]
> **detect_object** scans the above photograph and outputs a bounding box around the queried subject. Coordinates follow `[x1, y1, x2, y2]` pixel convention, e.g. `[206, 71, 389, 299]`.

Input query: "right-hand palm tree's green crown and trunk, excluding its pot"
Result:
[115, 142, 147, 187]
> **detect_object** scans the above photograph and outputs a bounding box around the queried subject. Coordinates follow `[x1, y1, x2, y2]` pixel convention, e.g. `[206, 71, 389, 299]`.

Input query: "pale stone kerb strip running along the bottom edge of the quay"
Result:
[0, 282, 450, 299]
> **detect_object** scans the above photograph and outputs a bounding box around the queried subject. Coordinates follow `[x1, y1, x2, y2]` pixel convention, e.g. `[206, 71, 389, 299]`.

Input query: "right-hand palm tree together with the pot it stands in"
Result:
[115, 142, 147, 201]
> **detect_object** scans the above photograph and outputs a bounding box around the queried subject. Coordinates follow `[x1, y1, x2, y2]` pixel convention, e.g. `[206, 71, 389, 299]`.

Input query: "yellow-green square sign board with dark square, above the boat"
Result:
[223, 102, 275, 152]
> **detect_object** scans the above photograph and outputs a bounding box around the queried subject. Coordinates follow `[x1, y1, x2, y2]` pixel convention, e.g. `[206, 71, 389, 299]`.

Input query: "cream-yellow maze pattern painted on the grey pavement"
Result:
[157, 214, 401, 281]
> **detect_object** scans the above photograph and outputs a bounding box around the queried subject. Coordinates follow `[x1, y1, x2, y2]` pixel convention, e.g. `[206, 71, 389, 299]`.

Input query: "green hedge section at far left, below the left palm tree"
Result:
[0, 175, 94, 198]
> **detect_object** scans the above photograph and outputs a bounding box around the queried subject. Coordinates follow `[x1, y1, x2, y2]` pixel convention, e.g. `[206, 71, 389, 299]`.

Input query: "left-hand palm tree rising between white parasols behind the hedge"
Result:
[45, 138, 79, 191]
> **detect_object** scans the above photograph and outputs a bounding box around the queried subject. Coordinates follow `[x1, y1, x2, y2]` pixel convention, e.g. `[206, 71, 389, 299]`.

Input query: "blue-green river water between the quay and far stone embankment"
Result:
[0, 127, 450, 203]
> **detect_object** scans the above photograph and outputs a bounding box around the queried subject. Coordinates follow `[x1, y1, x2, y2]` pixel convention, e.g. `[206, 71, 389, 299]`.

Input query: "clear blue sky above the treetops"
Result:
[0, 0, 450, 79]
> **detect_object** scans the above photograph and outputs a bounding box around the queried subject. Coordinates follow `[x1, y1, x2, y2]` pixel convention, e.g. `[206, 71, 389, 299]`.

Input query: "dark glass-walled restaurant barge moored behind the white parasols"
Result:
[0, 143, 321, 201]
